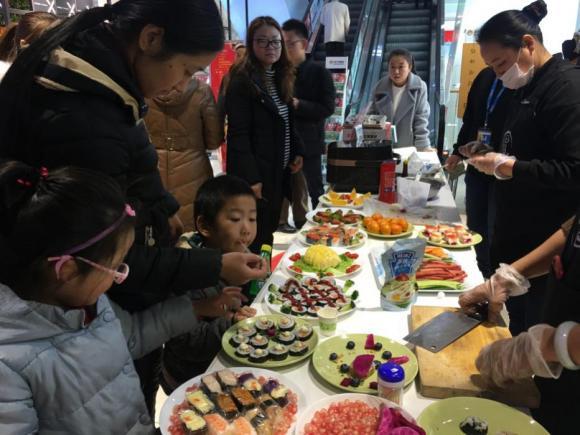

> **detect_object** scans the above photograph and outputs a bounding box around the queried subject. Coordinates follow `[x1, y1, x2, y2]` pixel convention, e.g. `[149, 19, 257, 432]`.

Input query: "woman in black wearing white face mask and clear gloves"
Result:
[467, 0, 580, 334]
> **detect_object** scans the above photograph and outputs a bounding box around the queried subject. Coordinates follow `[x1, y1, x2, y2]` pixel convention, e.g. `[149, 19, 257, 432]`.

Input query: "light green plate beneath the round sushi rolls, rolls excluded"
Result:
[222, 314, 318, 368]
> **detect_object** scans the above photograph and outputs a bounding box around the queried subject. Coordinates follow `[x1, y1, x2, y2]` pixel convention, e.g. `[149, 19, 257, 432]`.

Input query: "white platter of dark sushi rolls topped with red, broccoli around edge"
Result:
[266, 277, 359, 320]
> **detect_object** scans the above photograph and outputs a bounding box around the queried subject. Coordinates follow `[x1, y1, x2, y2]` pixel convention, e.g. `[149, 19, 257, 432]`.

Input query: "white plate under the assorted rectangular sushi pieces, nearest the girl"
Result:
[159, 367, 306, 435]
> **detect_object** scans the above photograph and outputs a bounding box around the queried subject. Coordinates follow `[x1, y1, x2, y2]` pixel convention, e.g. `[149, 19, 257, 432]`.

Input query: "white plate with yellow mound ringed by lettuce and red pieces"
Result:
[284, 245, 361, 278]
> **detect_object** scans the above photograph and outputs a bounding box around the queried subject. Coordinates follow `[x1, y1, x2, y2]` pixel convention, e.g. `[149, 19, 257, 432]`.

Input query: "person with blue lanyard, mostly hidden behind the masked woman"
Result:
[447, 68, 513, 278]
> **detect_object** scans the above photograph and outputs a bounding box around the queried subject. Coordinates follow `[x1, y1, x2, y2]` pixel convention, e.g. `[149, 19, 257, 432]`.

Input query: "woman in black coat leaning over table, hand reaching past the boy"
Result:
[0, 0, 263, 416]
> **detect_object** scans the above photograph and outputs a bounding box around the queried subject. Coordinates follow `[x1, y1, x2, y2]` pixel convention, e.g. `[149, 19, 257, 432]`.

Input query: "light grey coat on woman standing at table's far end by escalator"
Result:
[369, 73, 431, 149]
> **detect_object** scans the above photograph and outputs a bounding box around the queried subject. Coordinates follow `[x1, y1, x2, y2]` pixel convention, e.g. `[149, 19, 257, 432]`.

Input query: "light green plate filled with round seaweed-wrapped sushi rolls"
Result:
[222, 315, 318, 368]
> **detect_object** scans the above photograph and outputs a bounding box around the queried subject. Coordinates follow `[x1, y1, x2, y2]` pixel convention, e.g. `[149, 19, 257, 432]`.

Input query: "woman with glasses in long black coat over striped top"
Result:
[226, 17, 303, 252]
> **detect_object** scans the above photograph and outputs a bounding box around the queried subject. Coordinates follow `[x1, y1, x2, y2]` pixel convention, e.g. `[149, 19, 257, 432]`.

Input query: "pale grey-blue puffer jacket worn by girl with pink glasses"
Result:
[0, 284, 197, 435]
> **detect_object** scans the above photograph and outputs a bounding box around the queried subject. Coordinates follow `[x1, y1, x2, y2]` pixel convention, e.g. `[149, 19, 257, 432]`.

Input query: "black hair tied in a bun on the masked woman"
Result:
[477, 0, 548, 50]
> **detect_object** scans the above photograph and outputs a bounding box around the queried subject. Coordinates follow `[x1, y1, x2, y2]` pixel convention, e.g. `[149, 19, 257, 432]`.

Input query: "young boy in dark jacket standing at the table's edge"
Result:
[160, 175, 257, 394]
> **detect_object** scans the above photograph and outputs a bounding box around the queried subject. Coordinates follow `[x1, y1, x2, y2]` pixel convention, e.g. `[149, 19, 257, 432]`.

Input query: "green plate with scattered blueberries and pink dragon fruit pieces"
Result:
[312, 334, 419, 394]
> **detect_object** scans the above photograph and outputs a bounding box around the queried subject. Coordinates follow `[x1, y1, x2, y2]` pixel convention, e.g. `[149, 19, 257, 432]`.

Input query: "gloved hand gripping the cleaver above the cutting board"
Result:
[459, 263, 530, 322]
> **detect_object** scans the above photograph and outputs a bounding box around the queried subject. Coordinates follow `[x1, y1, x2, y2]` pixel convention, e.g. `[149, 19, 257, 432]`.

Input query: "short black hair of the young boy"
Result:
[193, 175, 256, 233]
